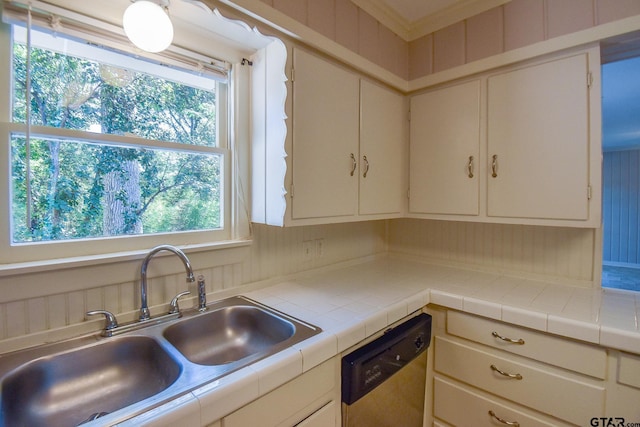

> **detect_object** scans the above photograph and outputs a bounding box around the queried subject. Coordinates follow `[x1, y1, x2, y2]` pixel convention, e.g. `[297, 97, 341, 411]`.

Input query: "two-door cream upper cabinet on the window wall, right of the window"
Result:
[253, 48, 408, 226]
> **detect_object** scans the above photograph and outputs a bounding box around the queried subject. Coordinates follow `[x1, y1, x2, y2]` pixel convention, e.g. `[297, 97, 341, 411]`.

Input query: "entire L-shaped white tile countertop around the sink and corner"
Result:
[116, 256, 640, 425]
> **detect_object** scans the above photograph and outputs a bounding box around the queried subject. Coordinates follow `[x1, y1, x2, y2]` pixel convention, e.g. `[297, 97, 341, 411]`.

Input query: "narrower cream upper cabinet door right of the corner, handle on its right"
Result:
[409, 80, 480, 215]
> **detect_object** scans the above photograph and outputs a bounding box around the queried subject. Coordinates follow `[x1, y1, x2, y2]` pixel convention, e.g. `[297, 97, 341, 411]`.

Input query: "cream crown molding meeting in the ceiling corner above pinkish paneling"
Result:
[351, 0, 511, 42]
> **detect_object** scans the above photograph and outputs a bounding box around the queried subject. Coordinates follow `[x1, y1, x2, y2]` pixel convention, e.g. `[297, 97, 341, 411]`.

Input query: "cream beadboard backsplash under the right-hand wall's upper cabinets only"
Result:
[388, 219, 599, 287]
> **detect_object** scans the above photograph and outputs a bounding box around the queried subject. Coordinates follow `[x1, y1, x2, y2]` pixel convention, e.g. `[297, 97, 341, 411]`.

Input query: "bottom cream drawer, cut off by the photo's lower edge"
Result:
[434, 377, 572, 427]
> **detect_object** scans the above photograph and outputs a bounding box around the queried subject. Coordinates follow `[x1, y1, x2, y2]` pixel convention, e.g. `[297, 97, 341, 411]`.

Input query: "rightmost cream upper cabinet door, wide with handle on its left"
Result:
[487, 54, 590, 220]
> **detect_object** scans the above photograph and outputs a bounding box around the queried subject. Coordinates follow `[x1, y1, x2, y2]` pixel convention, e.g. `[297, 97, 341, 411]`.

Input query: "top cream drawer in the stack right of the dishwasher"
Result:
[447, 311, 607, 379]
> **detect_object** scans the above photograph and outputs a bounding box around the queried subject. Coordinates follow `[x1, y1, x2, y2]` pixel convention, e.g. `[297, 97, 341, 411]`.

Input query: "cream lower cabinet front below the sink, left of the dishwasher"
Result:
[221, 358, 340, 427]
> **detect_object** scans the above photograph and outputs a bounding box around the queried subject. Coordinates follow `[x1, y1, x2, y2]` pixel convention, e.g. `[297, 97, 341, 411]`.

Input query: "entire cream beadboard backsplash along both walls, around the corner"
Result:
[0, 219, 596, 354]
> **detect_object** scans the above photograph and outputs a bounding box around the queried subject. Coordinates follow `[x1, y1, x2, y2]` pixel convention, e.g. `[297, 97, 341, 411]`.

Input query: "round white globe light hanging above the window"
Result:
[122, 0, 173, 52]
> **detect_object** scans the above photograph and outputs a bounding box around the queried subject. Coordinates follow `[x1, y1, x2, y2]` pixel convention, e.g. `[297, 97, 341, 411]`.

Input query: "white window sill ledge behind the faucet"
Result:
[0, 239, 253, 278]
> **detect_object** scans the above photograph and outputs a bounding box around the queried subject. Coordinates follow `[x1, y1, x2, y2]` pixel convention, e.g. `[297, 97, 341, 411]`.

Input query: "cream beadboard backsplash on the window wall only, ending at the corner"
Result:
[0, 221, 386, 354]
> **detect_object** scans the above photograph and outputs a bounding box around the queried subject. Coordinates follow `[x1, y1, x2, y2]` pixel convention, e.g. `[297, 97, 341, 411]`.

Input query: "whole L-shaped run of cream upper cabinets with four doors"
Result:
[252, 47, 601, 227]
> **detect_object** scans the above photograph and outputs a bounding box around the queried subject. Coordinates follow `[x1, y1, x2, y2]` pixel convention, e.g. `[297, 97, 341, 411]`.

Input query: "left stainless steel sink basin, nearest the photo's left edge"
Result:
[0, 336, 181, 426]
